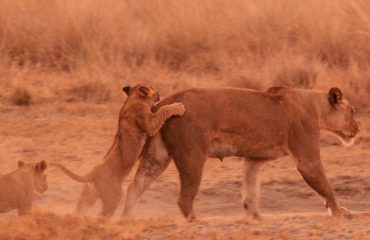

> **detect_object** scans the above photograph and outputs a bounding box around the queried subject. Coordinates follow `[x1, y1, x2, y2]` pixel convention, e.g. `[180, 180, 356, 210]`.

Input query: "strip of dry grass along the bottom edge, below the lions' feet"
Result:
[0, 211, 370, 240]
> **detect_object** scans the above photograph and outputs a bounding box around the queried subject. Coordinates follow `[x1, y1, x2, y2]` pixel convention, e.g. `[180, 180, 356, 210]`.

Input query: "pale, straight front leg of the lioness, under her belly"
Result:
[242, 159, 264, 219]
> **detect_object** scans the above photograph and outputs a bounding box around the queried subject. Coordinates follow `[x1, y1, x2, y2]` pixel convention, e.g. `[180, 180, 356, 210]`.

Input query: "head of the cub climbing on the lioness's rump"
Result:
[122, 84, 160, 106]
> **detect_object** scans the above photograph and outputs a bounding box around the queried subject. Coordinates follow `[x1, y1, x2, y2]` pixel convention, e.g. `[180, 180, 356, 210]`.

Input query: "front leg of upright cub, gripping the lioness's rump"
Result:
[139, 103, 185, 137]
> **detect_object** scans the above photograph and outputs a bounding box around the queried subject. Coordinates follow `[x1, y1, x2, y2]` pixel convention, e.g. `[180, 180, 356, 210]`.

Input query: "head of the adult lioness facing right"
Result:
[324, 87, 359, 143]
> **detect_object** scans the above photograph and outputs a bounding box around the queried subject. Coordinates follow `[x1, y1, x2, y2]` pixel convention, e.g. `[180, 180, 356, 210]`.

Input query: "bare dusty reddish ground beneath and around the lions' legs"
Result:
[0, 103, 370, 240]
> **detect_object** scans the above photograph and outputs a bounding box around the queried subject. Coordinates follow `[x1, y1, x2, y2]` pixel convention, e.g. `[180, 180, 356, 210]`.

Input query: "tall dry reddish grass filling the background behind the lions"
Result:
[0, 0, 370, 106]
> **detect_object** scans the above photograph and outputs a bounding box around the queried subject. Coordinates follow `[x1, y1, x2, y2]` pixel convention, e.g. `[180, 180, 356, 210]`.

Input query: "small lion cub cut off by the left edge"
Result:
[0, 161, 48, 216]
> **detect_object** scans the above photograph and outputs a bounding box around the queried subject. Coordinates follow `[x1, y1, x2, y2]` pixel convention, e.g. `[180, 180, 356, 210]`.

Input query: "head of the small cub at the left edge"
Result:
[18, 160, 48, 194]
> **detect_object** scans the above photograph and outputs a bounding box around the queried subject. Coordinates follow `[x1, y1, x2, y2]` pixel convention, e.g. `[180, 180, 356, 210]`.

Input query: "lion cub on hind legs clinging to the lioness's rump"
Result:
[51, 84, 185, 218]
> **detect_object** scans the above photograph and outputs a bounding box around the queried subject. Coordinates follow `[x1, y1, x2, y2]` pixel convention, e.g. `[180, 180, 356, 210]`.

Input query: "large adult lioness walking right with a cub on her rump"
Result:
[123, 88, 359, 220]
